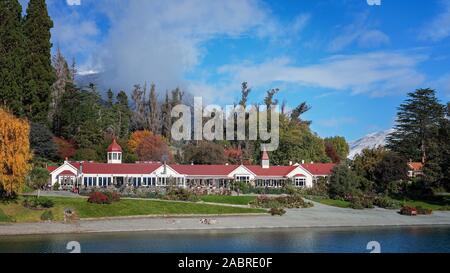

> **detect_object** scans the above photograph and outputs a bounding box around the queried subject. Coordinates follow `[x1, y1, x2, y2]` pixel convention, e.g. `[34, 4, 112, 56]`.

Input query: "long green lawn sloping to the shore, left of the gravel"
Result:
[0, 197, 265, 222]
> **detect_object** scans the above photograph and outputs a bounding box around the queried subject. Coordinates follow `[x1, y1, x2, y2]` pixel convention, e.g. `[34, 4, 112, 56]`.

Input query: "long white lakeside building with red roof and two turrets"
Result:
[48, 140, 335, 189]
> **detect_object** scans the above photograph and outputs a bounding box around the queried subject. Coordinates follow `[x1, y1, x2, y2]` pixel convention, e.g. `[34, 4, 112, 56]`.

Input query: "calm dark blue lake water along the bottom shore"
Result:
[0, 227, 450, 252]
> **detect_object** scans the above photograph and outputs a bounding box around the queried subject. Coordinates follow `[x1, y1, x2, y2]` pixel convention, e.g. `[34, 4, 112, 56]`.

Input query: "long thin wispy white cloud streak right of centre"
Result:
[218, 52, 427, 96]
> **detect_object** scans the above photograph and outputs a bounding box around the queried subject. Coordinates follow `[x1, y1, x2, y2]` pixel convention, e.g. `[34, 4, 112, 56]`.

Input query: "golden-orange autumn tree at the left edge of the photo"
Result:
[0, 108, 32, 195]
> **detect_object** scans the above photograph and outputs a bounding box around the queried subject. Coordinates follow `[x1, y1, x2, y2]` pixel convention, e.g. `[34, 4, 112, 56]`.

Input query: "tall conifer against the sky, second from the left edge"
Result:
[23, 0, 55, 122]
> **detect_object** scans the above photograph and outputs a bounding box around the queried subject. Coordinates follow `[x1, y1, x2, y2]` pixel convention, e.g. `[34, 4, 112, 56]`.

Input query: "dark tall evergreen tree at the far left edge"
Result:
[0, 0, 25, 116]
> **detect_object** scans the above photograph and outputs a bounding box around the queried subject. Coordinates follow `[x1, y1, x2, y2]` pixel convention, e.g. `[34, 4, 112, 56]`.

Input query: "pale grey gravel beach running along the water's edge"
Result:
[0, 200, 450, 235]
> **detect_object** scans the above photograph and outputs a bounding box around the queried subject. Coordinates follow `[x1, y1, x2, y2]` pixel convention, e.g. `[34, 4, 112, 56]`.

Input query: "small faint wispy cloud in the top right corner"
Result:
[419, 0, 450, 42]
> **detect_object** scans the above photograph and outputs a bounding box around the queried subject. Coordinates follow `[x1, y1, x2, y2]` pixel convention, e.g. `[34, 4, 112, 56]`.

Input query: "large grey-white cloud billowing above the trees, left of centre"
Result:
[89, 0, 276, 90]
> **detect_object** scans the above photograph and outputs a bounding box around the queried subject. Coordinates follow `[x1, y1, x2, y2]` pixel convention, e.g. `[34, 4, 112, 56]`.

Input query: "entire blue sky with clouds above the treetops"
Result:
[21, 0, 450, 140]
